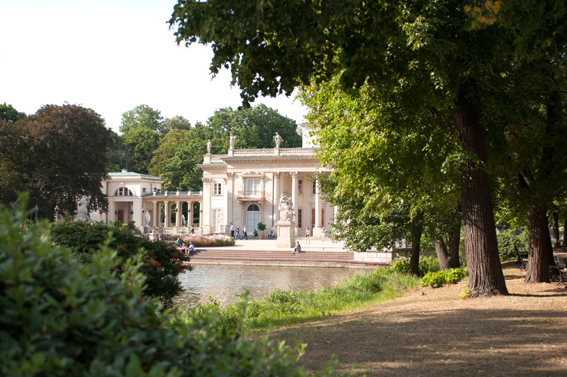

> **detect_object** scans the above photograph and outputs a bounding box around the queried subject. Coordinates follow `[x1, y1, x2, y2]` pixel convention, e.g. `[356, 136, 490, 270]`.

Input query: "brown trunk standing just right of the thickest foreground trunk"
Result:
[524, 207, 551, 283]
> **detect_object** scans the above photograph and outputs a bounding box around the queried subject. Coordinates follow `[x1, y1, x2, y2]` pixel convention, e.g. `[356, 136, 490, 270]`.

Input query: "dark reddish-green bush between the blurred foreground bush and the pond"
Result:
[52, 221, 189, 307]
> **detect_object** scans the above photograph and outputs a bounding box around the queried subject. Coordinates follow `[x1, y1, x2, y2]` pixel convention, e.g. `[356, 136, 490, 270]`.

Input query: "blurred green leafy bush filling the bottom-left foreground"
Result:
[0, 198, 320, 377]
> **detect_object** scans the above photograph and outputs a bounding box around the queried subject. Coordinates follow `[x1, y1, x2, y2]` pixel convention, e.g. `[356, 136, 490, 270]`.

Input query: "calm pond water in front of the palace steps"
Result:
[176, 264, 365, 307]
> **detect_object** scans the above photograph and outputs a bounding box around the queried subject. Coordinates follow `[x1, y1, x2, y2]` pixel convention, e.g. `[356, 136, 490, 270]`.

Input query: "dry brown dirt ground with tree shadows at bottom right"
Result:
[274, 265, 567, 377]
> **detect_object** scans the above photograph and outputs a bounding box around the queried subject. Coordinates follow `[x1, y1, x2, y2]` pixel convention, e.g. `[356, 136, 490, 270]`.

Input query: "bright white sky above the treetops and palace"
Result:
[0, 0, 307, 132]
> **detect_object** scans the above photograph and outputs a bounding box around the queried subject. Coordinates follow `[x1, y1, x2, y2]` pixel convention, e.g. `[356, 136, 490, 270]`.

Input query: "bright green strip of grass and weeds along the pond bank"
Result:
[194, 269, 418, 331]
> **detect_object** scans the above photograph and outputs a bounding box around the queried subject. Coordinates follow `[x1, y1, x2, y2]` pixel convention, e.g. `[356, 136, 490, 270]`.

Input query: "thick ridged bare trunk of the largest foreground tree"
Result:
[452, 80, 508, 297]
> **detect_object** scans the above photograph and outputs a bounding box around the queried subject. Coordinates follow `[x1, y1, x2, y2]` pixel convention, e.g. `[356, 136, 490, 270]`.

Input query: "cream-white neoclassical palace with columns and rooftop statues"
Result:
[97, 126, 336, 237]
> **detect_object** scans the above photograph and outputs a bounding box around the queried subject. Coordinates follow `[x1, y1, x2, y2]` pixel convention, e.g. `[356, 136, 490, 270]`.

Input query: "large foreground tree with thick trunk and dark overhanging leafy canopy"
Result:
[170, 0, 514, 296]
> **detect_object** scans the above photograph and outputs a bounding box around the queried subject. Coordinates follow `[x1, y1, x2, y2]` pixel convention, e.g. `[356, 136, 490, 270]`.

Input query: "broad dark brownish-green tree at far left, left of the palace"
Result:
[0, 104, 110, 218]
